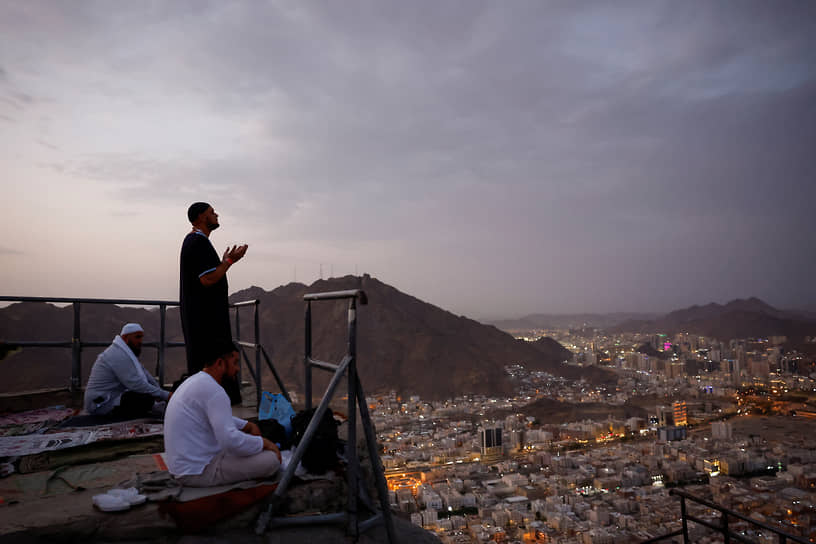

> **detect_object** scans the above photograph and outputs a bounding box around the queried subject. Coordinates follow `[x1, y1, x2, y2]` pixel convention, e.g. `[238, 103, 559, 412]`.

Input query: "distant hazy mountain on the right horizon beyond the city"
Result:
[609, 298, 816, 343]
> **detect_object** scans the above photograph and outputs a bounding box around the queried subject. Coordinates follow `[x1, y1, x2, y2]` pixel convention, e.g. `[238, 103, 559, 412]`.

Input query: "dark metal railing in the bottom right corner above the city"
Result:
[641, 489, 810, 544]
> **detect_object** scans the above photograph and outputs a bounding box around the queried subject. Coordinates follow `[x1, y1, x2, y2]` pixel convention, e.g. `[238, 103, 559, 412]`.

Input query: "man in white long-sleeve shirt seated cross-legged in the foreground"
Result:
[164, 340, 281, 487]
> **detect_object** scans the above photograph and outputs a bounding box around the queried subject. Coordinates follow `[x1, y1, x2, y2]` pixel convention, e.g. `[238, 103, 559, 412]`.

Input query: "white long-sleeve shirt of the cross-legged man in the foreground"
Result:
[164, 370, 263, 476]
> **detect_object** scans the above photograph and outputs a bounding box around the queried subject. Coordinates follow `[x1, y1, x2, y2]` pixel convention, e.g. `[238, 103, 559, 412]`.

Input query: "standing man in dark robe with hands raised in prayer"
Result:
[179, 202, 247, 404]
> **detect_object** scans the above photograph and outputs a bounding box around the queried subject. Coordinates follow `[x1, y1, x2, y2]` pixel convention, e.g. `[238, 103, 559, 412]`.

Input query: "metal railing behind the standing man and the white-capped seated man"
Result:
[0, 296, 274, 405]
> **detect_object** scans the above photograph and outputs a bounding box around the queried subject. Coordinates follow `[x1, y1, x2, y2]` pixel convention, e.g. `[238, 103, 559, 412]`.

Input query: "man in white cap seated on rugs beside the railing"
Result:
[85, 323, 170, 419]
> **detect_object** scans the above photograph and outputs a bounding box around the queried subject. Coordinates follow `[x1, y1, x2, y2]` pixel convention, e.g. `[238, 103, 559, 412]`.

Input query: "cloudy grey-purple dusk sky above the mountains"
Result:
[0, 0, 816, 318]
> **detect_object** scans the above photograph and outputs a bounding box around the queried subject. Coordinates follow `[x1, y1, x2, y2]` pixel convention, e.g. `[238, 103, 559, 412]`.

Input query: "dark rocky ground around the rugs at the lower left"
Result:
[0, 400, 439, 544]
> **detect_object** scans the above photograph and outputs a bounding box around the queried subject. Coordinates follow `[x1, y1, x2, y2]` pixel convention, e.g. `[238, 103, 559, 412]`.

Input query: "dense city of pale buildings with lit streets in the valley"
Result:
[369, 330, 816, 544]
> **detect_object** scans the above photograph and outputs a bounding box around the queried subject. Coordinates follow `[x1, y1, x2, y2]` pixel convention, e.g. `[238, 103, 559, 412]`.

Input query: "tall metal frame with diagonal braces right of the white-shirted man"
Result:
[255, 289, 397, 544]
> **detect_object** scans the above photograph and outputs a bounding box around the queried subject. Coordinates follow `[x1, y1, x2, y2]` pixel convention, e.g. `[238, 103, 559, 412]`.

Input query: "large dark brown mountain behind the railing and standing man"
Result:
[0, 275, 614, 398]
